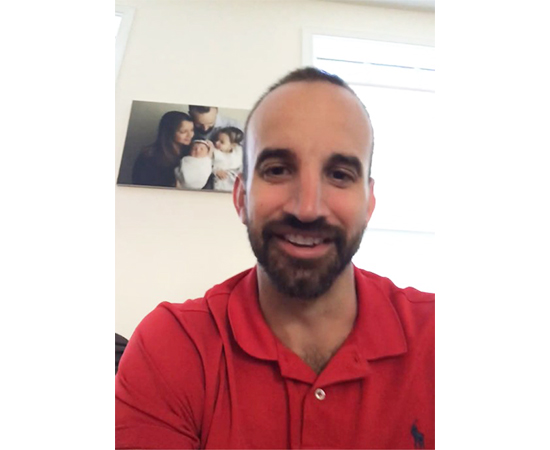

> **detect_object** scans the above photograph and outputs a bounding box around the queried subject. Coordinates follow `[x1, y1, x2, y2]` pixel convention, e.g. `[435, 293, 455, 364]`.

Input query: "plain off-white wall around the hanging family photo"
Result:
[114, 0, 434, 337]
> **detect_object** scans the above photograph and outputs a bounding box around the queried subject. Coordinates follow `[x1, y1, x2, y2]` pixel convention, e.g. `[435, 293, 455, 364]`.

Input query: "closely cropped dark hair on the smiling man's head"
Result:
[242, 66, 374, 181]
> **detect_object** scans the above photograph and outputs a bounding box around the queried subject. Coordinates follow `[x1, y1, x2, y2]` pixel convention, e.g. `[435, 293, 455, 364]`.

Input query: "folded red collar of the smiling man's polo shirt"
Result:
[228, 266, 407, 361]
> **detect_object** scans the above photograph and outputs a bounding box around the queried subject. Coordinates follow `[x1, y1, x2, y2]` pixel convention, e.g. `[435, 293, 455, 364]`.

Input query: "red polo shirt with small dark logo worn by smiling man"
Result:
[116, 268, 434, 449]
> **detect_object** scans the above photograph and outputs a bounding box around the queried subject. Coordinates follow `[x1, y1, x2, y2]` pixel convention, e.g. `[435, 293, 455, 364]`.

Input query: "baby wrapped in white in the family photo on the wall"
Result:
[175, 140, 212, 189]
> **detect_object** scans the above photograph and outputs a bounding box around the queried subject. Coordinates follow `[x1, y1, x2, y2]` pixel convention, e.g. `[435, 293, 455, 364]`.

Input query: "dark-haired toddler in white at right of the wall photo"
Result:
[212, 127, 244, 192]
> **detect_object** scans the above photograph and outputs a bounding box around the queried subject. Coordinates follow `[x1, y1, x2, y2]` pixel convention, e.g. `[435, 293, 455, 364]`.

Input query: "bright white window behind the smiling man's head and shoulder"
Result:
[304, 34, 436, 292]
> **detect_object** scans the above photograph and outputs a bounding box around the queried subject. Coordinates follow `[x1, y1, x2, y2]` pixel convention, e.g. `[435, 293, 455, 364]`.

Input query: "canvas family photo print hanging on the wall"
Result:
[121, 101, 249, 192]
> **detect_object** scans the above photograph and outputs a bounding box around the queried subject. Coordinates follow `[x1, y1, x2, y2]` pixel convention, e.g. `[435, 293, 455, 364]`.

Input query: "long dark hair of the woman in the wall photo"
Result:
[145, 111, 193, 166]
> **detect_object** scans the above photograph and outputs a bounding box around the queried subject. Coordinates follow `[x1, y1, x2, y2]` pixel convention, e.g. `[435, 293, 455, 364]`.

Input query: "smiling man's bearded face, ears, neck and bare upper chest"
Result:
[233, 81, 375, 371]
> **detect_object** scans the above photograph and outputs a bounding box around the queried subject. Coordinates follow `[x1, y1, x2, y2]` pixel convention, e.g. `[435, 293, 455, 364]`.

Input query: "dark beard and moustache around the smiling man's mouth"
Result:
[247, 215, 365, 300]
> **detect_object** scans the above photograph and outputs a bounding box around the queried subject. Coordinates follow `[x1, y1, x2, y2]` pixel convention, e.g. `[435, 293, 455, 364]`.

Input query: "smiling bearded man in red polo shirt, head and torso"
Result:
[116, 68, 435, 449]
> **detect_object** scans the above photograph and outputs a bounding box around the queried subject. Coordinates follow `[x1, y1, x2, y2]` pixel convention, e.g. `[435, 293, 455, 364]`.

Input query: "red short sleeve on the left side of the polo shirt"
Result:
[115, 304, 204, 449]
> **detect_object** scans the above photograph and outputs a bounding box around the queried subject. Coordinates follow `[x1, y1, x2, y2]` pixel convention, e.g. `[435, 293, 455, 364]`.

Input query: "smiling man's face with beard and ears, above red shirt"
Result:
[234, 82, 374, 299]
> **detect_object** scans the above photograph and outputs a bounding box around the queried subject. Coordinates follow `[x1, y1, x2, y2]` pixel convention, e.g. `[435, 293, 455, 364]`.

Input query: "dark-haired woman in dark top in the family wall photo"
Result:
[132, 111, 194, 187]
